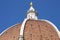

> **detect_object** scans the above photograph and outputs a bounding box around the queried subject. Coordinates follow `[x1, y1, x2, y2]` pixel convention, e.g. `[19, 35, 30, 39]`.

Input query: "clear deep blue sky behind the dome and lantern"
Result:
[0, 0, 60, 33]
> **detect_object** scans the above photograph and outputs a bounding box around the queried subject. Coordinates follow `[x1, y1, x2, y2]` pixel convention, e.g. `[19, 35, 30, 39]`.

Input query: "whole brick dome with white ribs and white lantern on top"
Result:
[0, 2, 60, 40]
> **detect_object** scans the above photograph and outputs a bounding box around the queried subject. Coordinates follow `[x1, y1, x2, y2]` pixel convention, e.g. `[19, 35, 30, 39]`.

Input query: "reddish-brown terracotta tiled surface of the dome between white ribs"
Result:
[0, 20, 59, 40]
